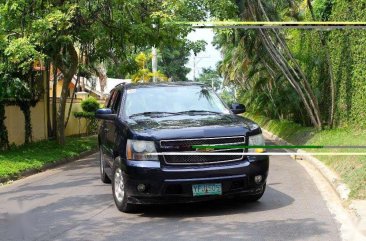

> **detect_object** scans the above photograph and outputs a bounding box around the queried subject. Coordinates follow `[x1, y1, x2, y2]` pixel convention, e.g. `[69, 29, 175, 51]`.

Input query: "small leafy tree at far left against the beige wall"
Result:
[0, 28, 42, 148]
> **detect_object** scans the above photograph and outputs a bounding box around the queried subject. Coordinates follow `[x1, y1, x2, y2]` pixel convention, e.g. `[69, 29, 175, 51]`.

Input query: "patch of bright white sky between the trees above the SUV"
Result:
[186, 29, 221, 80]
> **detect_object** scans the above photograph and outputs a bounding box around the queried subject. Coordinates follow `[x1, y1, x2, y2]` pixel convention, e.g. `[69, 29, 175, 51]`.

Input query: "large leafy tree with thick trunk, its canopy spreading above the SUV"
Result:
[1, 0, 210, 144]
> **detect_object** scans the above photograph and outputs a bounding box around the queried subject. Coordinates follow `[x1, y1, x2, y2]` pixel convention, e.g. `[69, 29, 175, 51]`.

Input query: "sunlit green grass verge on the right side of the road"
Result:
[244, 113, 366, 199]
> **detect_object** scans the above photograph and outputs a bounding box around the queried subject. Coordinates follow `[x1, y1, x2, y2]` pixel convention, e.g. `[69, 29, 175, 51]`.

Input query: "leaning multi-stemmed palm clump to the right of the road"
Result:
[210, 0, 322, 129]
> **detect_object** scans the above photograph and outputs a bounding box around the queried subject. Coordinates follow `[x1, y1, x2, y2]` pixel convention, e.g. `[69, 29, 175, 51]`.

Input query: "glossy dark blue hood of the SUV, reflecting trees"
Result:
[127, 114, 261, 140]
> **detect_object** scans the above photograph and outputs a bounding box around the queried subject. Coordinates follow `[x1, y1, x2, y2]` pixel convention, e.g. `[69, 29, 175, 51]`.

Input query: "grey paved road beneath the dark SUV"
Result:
[0, 144, 339, 241]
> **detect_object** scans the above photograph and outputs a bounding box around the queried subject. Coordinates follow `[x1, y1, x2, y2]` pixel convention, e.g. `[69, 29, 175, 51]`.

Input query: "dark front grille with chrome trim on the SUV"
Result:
[160, 136, 245, 165]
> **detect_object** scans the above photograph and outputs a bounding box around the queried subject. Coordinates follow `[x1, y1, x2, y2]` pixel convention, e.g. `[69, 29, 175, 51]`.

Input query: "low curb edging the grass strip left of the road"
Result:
[0, 148, 98, 185]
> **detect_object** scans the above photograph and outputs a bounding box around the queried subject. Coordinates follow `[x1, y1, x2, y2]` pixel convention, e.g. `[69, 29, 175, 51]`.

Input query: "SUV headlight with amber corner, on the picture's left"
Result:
[126, 140, 159, 161]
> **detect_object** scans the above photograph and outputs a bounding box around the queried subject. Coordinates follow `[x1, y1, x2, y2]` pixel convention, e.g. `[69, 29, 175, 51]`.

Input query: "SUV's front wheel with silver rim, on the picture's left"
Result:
[112, 166, 136, 213]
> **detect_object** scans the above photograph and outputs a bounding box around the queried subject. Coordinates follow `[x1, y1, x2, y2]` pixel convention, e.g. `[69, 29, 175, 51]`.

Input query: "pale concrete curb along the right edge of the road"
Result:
[262, 128, 366, 236]
